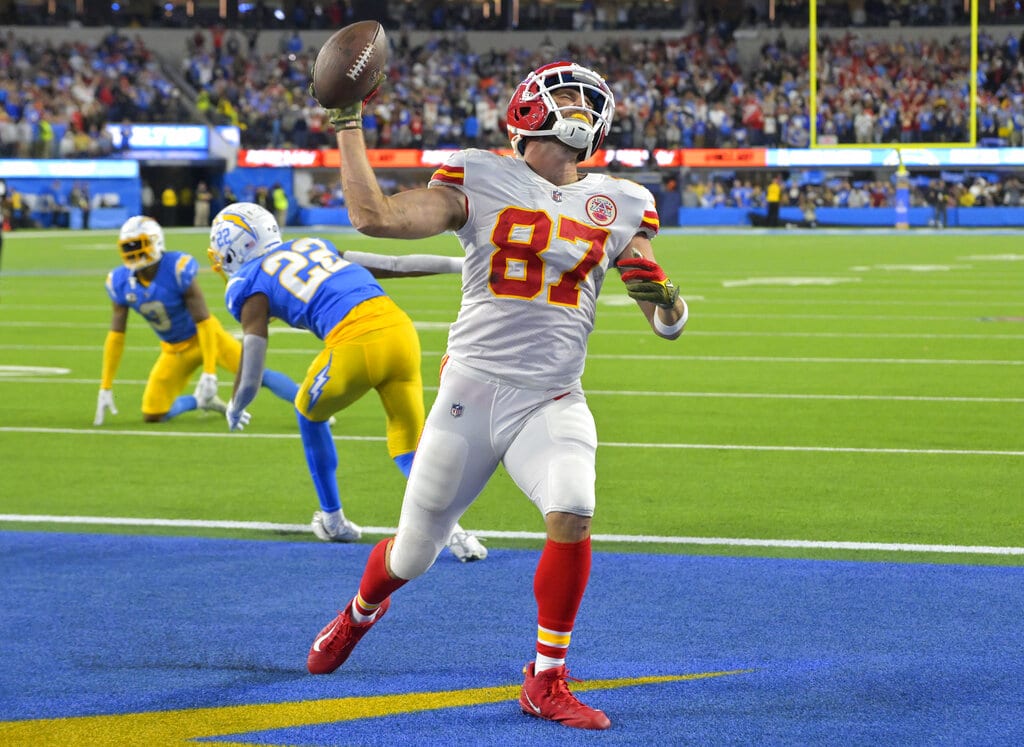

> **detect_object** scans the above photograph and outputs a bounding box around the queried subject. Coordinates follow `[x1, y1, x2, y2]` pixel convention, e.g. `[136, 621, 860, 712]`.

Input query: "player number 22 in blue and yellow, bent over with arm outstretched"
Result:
[210, 203, 486, 562]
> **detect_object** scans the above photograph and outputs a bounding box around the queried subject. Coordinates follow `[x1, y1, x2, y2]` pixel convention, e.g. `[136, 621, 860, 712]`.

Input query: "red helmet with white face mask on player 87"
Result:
[507, 63, 615, 161]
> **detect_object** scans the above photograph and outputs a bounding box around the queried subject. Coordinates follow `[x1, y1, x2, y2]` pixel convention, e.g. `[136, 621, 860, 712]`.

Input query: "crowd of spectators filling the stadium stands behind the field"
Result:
[0, 14, 1024, 220]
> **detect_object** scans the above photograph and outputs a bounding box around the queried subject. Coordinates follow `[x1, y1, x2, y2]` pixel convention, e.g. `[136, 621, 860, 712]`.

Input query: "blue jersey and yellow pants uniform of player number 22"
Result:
[224, 238, 424, 461]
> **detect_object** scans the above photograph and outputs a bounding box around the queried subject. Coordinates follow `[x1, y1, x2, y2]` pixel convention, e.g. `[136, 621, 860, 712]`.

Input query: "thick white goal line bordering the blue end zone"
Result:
[0, 513, 1024, 555]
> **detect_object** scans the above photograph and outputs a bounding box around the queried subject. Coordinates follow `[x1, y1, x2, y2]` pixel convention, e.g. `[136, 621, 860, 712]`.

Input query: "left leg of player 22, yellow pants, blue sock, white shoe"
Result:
[295, 344, 370, 542]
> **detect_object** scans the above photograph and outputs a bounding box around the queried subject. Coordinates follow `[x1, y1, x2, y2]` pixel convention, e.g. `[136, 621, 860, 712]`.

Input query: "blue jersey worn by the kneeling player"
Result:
[106, 252, 199, 343]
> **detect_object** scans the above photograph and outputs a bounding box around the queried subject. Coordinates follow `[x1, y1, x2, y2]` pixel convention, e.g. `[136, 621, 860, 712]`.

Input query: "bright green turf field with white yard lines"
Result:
[0, 231, 1024, 565]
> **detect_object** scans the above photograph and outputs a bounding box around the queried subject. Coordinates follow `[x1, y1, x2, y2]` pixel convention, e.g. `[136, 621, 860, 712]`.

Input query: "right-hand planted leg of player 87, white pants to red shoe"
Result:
[504, 392, 611, 729]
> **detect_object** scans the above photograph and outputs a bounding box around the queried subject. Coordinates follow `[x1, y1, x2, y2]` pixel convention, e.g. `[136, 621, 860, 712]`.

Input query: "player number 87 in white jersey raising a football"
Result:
[307, 63, 687, 729]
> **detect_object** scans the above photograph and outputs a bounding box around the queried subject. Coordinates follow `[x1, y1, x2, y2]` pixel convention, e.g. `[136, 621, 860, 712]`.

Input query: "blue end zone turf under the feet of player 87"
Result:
[0, 532, 1024, 747]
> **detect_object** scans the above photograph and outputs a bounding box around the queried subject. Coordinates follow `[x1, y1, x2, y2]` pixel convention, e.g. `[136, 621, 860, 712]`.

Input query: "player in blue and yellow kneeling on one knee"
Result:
[93, 215, 299, 425]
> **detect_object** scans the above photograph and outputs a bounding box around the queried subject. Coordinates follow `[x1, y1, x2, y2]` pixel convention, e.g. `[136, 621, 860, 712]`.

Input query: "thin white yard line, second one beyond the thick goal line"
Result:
[0, 379, 1024, 405]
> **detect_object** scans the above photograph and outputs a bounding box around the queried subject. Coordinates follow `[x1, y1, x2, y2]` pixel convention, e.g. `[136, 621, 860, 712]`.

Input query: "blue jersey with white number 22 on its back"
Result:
[224, 238, 385, 340]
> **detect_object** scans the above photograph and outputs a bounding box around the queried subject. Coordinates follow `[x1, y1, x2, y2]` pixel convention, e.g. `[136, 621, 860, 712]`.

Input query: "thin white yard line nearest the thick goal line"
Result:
[0, 426, 1024, 457]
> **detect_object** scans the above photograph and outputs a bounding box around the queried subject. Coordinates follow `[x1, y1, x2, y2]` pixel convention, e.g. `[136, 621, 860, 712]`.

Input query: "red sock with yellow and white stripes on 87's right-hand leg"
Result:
[534, 537, 591, 660]
